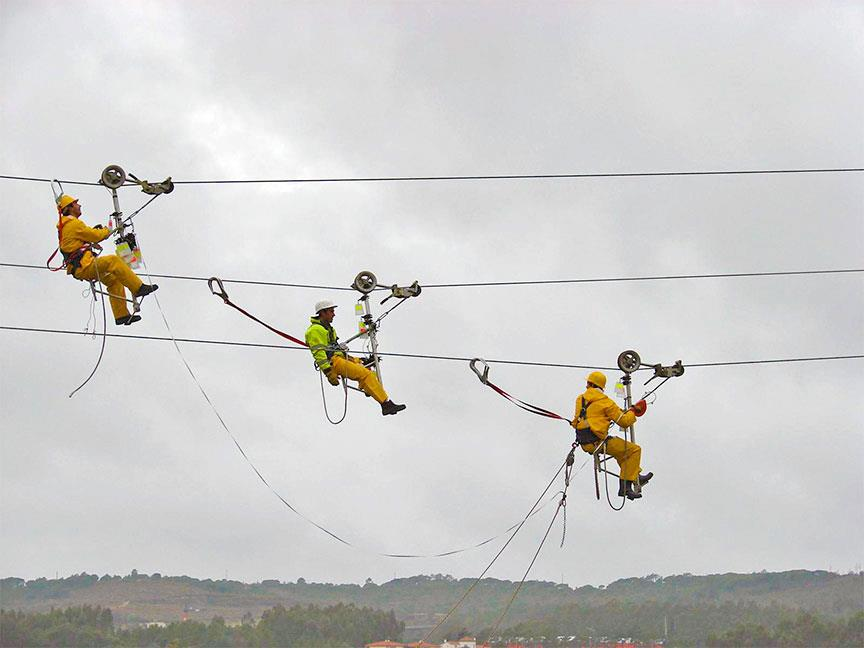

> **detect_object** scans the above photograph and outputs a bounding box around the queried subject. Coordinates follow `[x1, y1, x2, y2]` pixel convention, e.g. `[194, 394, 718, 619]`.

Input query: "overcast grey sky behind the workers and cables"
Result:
[0, 0, 864, 586]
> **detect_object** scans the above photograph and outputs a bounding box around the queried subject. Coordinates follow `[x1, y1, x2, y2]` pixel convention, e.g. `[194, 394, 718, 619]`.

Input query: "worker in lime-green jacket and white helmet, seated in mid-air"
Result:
[306, 300, 405, 416]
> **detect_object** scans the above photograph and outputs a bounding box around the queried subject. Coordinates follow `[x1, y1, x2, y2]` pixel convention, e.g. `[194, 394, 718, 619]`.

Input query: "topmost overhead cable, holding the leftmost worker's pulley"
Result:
[0, 167, 864, 187]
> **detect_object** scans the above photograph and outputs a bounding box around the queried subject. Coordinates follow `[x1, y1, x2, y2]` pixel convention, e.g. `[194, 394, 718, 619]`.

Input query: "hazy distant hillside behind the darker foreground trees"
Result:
[0, 570, 864, 637]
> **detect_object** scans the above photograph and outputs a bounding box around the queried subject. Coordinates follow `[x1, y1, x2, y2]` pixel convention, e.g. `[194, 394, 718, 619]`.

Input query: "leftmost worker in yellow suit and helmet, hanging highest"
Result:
[57, 194, 159, 325]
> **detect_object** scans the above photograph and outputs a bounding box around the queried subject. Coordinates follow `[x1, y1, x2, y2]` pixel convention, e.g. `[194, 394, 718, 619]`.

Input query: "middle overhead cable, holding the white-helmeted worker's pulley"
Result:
[0, 263, 864, 291]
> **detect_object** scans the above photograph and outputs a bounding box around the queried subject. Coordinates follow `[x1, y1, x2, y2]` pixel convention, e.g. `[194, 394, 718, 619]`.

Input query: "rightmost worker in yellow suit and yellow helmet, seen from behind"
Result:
[570, 371, 654, 500]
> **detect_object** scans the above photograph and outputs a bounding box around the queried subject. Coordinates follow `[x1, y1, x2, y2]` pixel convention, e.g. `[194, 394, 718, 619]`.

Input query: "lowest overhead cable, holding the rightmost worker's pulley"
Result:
[0, 325, 864, 371]
